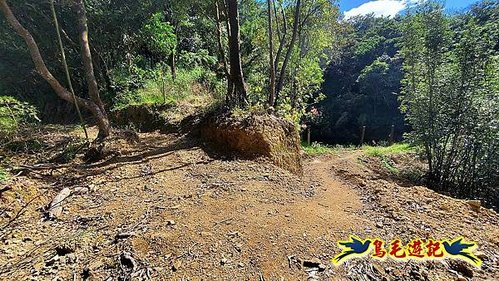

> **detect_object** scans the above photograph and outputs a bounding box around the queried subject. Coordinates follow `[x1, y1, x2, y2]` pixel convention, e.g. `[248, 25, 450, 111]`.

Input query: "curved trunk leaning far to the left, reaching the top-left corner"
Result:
[0, 0, 110, 137]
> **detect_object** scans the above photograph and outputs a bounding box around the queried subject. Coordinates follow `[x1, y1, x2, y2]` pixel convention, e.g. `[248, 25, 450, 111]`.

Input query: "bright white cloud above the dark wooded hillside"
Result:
[344, 0, 421, 19]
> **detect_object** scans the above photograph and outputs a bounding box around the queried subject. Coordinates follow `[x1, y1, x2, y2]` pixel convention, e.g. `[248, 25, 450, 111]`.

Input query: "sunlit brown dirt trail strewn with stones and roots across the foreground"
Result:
[0, 130, 499, 280]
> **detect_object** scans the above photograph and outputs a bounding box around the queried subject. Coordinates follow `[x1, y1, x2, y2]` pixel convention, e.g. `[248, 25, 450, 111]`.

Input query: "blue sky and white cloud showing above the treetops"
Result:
[340, 0, 479, 18]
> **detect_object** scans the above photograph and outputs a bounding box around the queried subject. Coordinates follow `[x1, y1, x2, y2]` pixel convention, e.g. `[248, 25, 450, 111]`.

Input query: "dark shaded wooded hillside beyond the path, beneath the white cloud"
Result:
[318, 15, 408, 143]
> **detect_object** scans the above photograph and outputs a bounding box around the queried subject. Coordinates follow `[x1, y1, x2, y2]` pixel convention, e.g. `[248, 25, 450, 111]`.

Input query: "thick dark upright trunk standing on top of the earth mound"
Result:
[227, 0, 248, 107]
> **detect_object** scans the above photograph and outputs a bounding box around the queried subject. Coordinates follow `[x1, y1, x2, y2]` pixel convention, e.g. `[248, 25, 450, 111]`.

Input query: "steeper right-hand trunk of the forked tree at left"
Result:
[75, 0, 111, 138]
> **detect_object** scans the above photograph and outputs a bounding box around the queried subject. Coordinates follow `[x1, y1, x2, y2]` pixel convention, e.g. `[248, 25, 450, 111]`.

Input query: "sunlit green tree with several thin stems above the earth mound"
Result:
[240, 0, 339, 119]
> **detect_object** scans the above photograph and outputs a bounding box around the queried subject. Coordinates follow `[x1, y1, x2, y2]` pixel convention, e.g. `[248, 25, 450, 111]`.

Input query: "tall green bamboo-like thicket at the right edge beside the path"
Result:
[401, 3, 499, 204]
